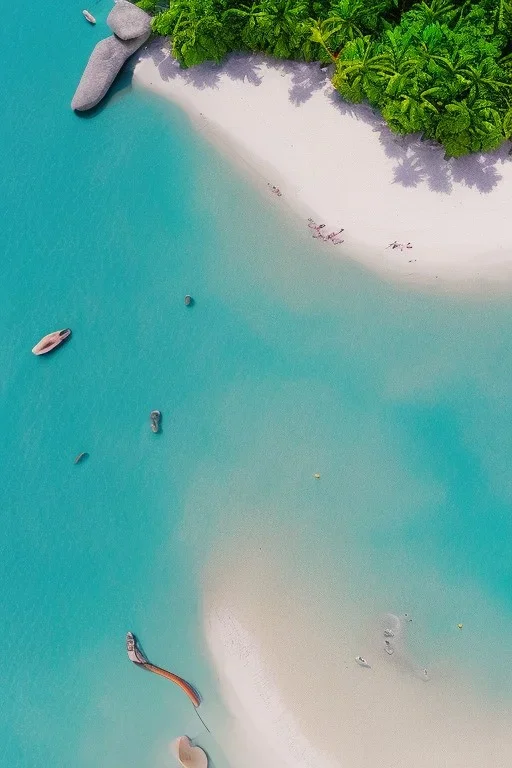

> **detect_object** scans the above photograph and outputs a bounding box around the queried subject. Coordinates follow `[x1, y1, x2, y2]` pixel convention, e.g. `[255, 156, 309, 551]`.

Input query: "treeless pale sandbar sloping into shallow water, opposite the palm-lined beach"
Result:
[204, 551, 512, 768]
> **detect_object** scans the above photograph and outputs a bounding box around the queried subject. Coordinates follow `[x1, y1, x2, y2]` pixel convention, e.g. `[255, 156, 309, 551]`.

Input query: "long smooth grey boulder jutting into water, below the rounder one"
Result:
[71, 32, 150, 112]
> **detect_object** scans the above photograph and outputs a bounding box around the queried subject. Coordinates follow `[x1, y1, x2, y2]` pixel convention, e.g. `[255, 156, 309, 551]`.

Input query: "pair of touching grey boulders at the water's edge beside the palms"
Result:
[71, 0, 151, 112]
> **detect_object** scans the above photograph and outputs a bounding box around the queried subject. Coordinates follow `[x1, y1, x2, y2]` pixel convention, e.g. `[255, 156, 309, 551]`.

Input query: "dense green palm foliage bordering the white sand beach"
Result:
[139, 0, 512, 156]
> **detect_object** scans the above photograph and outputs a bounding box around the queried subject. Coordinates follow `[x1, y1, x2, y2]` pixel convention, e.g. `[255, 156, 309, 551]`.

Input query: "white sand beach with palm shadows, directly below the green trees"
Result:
[133, 41, 512, 291]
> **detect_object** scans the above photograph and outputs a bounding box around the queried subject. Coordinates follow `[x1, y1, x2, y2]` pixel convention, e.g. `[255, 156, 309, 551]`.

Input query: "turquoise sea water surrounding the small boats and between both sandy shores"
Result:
[0, 0, 512, 768]
